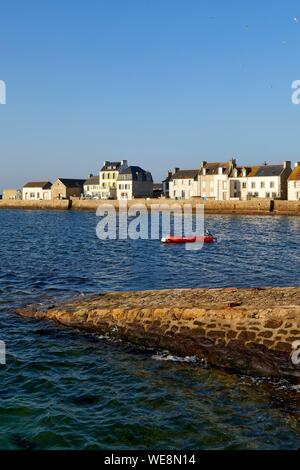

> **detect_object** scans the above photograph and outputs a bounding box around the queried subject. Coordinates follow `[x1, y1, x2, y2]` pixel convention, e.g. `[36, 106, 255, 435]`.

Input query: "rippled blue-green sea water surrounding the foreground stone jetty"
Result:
[0, 210, 300, 449]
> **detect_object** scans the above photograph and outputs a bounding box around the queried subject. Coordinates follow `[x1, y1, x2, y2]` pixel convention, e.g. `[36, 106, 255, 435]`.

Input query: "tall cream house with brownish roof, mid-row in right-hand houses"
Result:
[198, 159, 236, 201]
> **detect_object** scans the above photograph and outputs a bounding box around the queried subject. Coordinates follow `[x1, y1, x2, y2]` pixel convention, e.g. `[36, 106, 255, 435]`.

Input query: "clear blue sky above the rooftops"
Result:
[0, 0, 300, 189]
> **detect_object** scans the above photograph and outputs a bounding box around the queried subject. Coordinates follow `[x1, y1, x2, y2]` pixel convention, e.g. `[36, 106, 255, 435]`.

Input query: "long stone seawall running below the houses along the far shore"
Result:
[0, 198, 300, 216]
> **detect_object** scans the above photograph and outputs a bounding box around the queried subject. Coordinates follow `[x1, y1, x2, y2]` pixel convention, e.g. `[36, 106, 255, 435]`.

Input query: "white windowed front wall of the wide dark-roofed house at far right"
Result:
[247, 176, 281, 199]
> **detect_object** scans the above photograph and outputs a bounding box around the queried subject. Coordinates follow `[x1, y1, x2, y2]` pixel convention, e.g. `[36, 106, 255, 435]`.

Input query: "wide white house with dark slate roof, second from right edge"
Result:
[247, 161, 292, 199]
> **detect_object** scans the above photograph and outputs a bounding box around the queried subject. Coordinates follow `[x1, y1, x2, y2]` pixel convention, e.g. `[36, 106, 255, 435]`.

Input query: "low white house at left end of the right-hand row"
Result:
[169, 168, 199, 199]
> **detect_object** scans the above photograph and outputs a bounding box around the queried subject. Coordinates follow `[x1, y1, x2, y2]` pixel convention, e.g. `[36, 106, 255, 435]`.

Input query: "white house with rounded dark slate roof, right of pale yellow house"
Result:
[117, 166, 153, 200]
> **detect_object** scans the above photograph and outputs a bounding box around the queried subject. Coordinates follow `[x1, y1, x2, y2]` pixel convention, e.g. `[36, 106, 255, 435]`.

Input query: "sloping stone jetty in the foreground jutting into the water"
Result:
[17, 287, 300, 382]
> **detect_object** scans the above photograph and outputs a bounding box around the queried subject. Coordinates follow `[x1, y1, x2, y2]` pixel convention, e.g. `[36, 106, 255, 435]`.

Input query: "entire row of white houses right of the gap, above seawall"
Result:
[169, 159, 300, 201]
